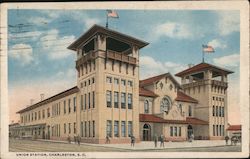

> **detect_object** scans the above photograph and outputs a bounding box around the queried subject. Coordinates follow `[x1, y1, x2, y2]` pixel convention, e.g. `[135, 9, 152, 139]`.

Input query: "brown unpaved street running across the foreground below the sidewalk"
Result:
[9, 139, 241, 152]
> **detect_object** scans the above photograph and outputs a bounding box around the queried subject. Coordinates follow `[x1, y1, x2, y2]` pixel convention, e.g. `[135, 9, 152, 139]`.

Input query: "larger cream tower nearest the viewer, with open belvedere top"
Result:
[68, 25, 148, 143]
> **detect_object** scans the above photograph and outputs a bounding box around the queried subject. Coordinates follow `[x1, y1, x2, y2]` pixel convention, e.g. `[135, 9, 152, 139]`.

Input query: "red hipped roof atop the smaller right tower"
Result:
[175, 62, 233, 77]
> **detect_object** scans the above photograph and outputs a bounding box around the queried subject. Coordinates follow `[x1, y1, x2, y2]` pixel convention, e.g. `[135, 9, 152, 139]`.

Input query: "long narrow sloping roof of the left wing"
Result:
[17, 86, 79, 113]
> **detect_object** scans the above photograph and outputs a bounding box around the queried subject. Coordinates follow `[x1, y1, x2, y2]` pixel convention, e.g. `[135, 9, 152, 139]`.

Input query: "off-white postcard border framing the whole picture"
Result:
[0, 1, 249, 159]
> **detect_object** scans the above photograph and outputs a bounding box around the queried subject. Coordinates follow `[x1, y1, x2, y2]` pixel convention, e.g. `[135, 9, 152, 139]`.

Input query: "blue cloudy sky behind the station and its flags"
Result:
[8, 9, 240, 123]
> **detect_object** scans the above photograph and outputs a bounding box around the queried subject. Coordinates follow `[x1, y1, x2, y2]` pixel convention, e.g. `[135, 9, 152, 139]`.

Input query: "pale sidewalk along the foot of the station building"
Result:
[38, 139, 236, 150]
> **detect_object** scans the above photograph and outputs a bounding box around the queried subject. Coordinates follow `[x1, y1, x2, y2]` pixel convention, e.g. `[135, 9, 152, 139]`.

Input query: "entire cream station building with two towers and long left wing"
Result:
[9, 25, 233, 143]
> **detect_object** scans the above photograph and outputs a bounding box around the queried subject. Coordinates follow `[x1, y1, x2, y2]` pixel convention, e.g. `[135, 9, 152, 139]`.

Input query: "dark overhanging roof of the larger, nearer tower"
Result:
[68, 24, 149, 51]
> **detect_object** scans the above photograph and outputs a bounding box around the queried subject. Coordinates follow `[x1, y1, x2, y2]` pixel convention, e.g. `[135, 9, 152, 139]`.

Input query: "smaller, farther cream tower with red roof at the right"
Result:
[176, 63, 233, 139]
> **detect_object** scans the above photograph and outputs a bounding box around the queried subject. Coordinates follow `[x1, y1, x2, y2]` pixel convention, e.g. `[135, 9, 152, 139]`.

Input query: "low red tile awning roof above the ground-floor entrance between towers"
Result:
[139, 114, 208, 125]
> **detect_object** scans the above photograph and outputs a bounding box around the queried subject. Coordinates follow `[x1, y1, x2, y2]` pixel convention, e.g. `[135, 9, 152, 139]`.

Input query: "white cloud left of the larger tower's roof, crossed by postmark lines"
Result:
[40, 29, 75, 60]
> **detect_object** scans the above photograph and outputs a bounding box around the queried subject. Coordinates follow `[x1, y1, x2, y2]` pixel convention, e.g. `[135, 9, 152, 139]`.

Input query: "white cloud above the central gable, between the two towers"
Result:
[140, 56, 187, 79]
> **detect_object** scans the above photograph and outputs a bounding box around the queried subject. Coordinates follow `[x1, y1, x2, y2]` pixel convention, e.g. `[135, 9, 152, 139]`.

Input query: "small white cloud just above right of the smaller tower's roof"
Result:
[213, 53, 240, 67]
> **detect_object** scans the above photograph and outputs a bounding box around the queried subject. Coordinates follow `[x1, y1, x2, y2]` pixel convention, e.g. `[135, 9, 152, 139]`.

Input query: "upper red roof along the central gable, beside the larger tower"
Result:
[140, 73, 180, 88]
